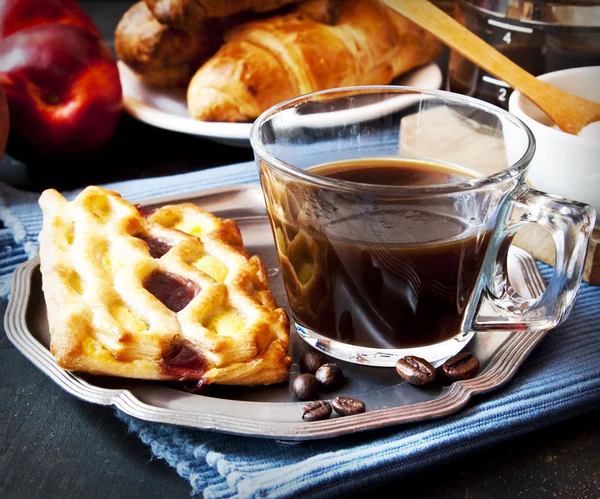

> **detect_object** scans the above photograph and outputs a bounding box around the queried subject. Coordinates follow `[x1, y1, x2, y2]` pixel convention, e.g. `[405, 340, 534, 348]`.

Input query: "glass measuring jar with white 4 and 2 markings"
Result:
[446, 0, 600, 109]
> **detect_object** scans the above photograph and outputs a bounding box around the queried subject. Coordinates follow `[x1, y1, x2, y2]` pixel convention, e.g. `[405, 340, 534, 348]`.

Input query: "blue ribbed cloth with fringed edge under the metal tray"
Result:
[0, 163, 600, 499]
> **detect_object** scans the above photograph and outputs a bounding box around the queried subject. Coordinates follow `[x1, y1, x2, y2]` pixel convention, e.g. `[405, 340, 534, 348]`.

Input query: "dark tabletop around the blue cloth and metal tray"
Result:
[0, 0, 600, 499]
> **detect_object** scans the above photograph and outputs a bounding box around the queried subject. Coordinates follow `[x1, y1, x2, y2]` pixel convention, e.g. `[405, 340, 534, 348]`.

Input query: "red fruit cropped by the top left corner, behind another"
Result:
[0, 0, 102, 39]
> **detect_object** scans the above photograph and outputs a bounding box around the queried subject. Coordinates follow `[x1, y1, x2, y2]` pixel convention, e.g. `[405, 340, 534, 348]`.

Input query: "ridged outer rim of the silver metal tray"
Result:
[4, 184, 547, 440]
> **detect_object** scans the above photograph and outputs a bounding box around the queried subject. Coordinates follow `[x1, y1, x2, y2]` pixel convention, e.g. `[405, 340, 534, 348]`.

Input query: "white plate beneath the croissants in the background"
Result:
[118, 61, 443, 147]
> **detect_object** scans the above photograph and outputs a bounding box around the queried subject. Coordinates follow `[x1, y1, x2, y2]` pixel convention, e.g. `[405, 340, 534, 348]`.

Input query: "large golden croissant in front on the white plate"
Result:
[187, 0, 443, 122]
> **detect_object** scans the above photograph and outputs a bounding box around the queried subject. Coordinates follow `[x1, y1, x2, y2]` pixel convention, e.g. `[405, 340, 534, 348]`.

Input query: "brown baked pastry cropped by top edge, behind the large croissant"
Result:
[145, 0, 301, 32]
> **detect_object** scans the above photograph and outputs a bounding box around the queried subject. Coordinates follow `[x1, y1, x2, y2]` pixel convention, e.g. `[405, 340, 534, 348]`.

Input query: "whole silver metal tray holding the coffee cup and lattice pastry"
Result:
[5, 185, 546, 441]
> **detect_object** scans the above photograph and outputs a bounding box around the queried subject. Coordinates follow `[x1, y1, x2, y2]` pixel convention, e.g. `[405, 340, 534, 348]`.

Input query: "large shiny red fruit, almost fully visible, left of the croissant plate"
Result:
[0, 24, 122, 155]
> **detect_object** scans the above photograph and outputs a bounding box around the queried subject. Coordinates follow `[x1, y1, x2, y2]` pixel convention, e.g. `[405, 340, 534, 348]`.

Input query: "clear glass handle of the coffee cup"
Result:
[473, 185, 596, 331]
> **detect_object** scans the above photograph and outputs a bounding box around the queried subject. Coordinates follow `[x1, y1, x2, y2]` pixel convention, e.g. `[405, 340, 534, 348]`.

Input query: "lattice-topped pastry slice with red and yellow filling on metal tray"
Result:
[39, 186, 291, 385]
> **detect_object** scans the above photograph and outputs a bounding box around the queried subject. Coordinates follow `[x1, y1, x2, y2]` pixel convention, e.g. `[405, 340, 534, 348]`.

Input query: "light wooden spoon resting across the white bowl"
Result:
[382, 0, 600, 135]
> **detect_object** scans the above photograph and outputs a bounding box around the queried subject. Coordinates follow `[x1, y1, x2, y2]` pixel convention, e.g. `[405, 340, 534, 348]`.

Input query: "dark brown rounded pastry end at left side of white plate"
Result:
[115, 1, 222, 87]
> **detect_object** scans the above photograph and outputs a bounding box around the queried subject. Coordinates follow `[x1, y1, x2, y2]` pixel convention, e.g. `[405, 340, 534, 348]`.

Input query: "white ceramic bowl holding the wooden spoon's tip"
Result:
[508, 66, 600, 227]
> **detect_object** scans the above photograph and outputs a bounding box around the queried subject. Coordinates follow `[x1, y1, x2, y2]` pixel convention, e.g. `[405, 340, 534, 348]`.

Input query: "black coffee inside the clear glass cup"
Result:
[270, 159, 490, 348]
